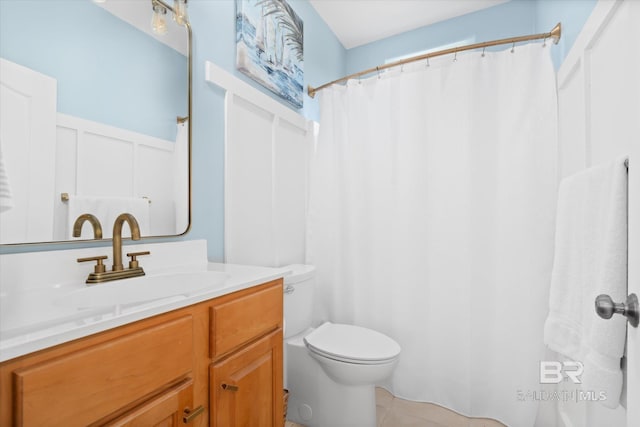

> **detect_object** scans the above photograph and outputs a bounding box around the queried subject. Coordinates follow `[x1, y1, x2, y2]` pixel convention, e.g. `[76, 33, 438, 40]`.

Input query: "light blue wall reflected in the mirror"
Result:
[0, 0, 187, 140]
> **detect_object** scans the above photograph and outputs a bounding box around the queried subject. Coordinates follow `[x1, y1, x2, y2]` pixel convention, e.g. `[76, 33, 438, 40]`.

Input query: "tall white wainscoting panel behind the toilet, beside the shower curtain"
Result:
[206, 62, 313, 267]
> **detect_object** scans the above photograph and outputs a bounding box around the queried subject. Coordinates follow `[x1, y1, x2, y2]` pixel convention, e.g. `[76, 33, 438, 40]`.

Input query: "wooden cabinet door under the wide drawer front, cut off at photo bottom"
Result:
[106, 378, 202, 427]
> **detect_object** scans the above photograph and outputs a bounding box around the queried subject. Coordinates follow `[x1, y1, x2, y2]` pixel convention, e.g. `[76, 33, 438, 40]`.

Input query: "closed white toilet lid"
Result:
[304, 322, 400, 363]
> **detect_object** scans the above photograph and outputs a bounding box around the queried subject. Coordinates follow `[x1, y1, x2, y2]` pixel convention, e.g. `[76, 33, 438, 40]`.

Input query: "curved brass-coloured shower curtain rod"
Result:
[307, 23, 562, 98]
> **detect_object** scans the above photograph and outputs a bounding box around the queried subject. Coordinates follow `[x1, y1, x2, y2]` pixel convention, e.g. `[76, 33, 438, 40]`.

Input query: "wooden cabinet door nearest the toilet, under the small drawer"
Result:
[210, 329, 283, 427]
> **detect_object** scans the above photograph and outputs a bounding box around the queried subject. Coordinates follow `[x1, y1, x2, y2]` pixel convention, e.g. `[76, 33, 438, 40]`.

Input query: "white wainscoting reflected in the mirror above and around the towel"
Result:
[54, 113, 175, 240]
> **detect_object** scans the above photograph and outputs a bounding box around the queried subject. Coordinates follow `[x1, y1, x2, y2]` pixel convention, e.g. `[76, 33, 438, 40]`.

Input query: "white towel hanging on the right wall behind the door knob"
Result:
[544, 159, 627, 408]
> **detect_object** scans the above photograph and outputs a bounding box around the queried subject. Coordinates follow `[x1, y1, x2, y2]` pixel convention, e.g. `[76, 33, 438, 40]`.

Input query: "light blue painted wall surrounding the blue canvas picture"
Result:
[185, 0, 346, 261]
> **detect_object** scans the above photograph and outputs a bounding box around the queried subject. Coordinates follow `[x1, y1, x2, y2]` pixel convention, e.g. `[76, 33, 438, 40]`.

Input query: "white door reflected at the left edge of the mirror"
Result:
[0, 58, 56, 244]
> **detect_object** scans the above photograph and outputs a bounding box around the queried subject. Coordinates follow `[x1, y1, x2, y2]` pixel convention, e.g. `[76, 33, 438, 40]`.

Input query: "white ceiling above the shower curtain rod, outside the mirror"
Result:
[309, 0, 509, 49]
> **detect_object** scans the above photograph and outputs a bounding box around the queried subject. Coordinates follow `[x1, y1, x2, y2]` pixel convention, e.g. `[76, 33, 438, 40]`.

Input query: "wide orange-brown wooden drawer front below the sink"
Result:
[14, 315, 193, 427]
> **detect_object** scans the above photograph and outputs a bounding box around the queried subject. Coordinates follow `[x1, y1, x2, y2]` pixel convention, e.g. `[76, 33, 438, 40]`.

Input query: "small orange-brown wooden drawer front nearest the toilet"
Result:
[211, 281, 282, 358]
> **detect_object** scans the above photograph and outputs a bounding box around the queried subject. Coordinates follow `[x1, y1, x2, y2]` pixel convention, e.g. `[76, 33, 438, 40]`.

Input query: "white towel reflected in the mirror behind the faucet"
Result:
[67, 194, 149, 239]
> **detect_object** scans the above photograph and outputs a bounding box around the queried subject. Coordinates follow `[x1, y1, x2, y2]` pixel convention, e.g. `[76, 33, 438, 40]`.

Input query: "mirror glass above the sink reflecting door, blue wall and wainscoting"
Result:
[0, 0, 190, 244]
